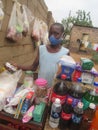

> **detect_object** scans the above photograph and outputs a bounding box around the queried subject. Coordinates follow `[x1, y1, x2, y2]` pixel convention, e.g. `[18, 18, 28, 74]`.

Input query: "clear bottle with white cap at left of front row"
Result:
[49, 98, 61, 128]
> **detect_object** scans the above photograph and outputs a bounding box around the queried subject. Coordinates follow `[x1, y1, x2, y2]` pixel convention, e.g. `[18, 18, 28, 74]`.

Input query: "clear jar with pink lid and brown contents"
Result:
[35, 78, 47, 99]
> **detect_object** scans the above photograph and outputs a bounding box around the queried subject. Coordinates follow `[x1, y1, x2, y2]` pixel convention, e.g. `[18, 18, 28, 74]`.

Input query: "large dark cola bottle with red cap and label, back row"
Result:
[51, 75, 68, 104]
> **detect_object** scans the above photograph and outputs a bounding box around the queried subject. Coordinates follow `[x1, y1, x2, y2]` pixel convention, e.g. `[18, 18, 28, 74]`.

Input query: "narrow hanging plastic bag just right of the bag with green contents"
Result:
[22, 5, 34, 36]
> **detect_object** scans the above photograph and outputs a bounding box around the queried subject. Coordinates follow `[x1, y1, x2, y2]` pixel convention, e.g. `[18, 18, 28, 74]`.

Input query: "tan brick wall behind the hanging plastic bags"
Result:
[0, 0, 54, 66]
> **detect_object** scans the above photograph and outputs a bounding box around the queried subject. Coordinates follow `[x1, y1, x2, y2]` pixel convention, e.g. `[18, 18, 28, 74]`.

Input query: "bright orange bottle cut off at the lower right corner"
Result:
[89, 107, 98, 130]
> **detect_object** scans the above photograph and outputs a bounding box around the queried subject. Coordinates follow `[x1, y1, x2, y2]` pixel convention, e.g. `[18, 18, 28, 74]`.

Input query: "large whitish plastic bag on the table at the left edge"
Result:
[0, 70, 22, 111]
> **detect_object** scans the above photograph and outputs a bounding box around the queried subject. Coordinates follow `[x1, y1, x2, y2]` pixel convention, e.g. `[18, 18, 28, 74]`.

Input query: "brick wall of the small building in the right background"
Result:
[70, 25, 98, 48]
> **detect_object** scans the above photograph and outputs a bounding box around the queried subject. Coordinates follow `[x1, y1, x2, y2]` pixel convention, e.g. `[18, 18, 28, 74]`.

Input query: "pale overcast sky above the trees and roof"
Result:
[44, 0, 98, 27]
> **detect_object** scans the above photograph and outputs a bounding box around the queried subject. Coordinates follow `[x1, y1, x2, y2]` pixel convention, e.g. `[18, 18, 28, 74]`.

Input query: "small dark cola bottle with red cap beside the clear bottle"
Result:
[59, 98, 73, 130]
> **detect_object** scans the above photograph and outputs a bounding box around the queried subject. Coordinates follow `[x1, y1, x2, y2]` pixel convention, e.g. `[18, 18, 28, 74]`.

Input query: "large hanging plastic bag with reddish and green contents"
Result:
[6, 2, 23, 41]
